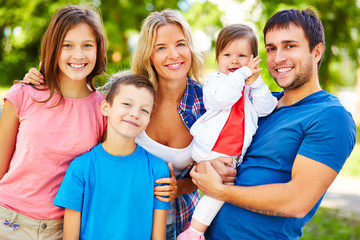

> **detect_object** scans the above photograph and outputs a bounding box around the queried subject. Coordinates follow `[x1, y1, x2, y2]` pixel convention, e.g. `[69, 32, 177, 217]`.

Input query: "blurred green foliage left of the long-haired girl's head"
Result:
[0, 0, 85, 85]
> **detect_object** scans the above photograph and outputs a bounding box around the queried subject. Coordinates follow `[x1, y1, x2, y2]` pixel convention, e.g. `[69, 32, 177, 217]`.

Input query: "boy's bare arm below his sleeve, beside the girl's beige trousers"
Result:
[63, 208, 81, 240]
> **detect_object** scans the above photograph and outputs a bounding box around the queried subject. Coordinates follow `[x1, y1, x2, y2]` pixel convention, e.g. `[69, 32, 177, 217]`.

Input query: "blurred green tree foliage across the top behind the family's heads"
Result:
[0, 0, 360, 92]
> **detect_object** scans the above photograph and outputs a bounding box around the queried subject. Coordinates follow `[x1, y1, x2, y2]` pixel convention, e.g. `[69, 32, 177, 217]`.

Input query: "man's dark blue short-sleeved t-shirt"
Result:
[206, 91, 356, 240]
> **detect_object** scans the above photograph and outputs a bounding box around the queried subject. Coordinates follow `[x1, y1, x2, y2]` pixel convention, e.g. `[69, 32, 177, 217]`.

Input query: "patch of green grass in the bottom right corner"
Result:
[301, 207, 360, 240]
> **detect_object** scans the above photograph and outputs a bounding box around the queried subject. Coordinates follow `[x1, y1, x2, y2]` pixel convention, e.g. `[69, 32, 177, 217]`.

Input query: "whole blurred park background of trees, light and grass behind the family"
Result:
[0, 0, 360, 239]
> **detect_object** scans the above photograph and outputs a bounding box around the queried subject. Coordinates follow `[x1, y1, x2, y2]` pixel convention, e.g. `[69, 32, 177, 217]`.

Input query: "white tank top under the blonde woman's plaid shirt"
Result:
[135, 131, 193, 224]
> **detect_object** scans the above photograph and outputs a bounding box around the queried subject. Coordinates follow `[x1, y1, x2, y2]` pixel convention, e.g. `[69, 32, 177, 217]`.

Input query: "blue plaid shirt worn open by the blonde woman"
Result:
[175, 78, 206, 235]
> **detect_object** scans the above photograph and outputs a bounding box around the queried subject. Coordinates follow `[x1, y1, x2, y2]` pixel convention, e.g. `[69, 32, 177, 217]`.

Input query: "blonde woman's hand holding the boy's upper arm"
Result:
[154, 162, 180, 202]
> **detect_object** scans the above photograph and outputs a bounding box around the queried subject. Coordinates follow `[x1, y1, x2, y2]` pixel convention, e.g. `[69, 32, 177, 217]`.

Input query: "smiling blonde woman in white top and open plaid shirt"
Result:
[131, 10, 205, 239]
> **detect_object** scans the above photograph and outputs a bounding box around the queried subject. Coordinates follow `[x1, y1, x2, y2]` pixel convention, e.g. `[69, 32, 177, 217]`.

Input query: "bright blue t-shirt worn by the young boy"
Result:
[54, 144, 170, 240]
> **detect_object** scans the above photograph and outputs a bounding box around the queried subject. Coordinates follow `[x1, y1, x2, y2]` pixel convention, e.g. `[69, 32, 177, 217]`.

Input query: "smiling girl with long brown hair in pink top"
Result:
[0, 6, 107, 239]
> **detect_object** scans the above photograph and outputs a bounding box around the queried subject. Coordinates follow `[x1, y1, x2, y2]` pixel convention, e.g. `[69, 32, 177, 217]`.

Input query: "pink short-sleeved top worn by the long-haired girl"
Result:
[0, 84, 106, 220]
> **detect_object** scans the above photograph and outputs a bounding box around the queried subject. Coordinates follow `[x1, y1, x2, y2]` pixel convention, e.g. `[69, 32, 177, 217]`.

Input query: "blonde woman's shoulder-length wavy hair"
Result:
[131, 9, 203, 89]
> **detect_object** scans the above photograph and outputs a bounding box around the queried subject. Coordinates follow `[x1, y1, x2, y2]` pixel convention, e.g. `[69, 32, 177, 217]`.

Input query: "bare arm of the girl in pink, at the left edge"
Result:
[0, 100, 19, 179]
